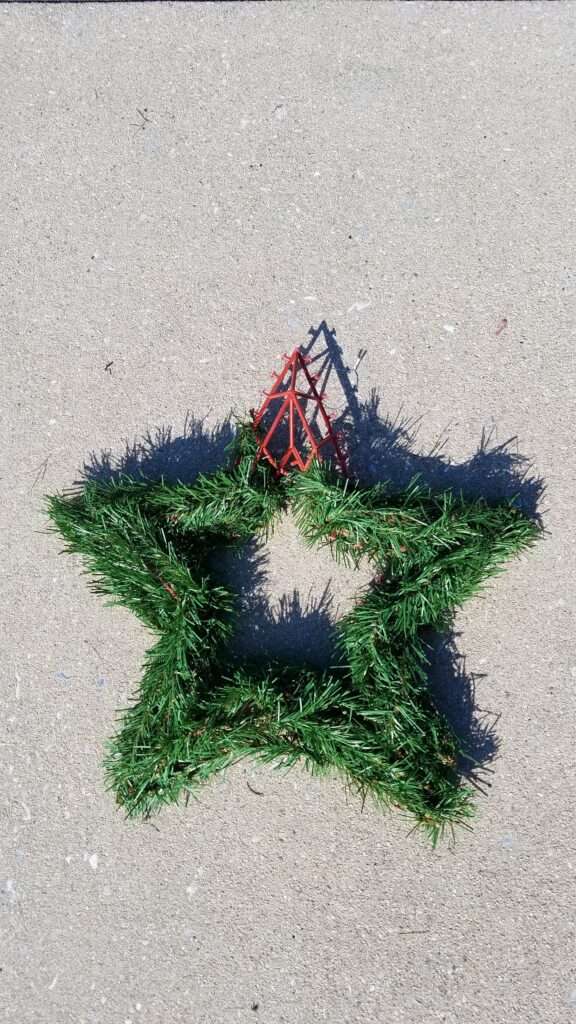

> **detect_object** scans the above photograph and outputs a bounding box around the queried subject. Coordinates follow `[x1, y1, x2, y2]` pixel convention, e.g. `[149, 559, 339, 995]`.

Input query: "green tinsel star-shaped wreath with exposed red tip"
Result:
[48, 350, 539, 843]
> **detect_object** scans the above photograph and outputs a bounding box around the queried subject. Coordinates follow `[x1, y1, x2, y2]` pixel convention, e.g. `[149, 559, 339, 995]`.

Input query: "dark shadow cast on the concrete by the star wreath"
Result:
[80, 321, 544, 791]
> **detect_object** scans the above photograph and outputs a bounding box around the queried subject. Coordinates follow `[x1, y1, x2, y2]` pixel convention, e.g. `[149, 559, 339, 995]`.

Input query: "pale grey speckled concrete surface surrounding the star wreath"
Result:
[0, 2, 576, 1024]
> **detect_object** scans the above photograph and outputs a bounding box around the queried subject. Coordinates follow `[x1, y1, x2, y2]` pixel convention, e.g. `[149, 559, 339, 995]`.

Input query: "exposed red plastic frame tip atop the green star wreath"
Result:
[252, 348, 348, 476]
